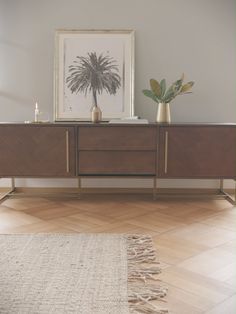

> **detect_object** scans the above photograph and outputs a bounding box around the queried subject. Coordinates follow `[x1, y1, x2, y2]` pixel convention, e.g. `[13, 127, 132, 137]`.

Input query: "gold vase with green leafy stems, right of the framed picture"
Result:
[143, 74, 194, 123]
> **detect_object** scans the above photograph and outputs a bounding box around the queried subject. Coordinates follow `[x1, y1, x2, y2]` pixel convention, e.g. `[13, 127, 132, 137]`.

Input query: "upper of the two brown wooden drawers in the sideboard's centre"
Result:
[78, 125, 157, 151]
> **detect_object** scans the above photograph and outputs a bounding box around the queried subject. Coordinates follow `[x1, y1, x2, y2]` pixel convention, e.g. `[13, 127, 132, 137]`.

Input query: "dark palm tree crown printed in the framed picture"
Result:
[66, 52, 121, 107]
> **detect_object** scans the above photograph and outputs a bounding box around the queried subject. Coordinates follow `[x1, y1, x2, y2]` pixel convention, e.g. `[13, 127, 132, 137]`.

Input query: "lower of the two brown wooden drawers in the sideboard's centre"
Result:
[78, 151, 156, 175]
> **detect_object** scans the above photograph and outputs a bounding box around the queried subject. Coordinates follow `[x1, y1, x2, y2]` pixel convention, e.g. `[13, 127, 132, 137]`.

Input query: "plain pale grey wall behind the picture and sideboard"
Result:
[0, 0, 236, 186]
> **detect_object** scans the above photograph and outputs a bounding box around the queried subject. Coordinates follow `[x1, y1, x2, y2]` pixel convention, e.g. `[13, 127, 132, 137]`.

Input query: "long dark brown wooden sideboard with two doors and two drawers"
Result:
[0, 122, 236, 204]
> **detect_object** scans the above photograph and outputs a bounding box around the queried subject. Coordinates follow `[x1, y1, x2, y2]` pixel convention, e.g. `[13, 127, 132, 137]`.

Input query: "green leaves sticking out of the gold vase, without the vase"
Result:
[143, 74, 194, 103]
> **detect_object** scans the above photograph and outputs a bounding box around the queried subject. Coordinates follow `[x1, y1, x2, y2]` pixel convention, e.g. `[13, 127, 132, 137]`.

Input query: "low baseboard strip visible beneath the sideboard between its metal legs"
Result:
[0, 187, 234, 195]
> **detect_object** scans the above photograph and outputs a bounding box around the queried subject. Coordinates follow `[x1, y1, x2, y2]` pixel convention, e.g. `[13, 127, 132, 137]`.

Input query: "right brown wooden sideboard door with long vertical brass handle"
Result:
[158, 125, 236, 178]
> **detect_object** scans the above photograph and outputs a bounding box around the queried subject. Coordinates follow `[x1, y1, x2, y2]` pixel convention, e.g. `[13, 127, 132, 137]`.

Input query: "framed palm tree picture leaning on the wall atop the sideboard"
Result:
[54, 30, 134, 121]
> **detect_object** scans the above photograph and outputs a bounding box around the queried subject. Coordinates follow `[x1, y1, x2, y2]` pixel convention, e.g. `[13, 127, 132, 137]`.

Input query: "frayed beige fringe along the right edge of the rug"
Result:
[127, 235, 168, 314]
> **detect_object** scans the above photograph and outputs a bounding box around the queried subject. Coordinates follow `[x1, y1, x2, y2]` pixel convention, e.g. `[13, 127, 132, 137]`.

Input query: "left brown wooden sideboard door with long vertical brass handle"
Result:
[0, 125, 75, 177]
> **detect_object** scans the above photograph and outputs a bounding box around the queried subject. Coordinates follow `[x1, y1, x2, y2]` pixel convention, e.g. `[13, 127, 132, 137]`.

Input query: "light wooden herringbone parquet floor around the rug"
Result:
[0, 195, 236, 314]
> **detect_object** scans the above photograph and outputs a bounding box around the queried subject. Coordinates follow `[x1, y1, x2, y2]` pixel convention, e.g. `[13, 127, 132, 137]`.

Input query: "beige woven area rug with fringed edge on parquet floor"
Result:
[0, 234, 167, 314]
